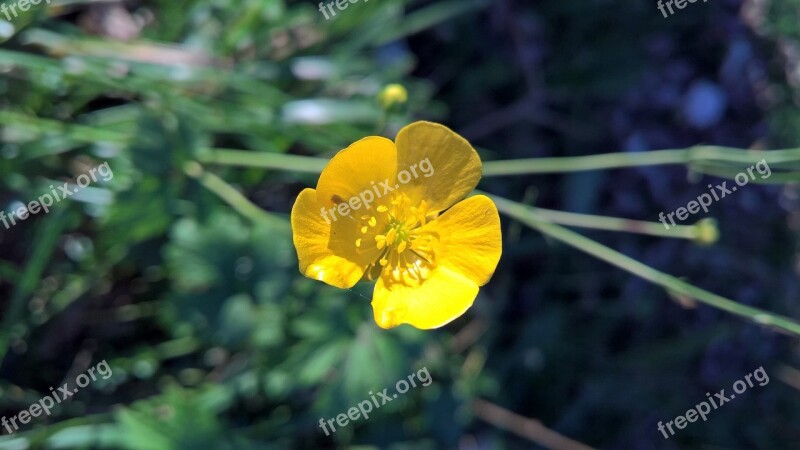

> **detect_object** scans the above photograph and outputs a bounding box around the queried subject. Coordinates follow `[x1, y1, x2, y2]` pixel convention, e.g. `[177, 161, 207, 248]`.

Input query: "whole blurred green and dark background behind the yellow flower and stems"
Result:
[0, 0, 800, 450]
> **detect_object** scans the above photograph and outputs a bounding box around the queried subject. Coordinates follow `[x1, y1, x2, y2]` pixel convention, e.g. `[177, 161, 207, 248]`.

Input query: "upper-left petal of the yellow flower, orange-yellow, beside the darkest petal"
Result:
[317, 136, 397, 208]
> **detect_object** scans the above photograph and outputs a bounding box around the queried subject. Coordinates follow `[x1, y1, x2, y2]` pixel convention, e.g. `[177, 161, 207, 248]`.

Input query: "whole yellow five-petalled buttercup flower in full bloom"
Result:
[292, 122, 502, 329]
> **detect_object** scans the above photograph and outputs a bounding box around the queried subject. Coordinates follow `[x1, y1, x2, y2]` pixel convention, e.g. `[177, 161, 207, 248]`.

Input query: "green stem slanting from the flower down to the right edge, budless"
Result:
[490, 195, 800, 336]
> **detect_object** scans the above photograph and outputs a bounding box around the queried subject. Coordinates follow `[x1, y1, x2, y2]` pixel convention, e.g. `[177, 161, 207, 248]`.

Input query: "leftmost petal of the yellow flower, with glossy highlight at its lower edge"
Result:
[291, 188, 377, 288]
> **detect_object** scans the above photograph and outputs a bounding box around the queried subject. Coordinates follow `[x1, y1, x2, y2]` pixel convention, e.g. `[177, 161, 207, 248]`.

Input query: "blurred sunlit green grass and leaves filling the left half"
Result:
[0, 0, 488, 449]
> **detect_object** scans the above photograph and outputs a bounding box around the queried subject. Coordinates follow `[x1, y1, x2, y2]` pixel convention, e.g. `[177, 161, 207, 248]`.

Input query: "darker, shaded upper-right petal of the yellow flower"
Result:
[395, 122, 481, 212]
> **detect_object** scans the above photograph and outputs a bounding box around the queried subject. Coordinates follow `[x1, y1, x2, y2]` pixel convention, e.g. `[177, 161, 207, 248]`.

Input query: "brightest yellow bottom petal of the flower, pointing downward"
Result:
[372, 266, 478, 330]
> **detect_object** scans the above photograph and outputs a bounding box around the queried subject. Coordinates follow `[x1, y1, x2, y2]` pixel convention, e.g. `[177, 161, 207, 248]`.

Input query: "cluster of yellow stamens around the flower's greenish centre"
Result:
[355, 193, 438, 286]
